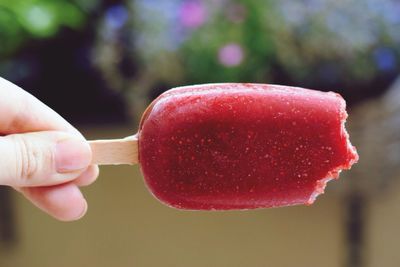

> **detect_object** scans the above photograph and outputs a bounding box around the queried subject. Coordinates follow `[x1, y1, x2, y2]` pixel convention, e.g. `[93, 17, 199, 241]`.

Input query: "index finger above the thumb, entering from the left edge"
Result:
[0, 77, 81, 136]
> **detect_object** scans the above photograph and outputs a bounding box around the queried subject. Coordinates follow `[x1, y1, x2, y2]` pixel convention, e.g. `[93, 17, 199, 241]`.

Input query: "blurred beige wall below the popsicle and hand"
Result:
[0, 127, 400, 267]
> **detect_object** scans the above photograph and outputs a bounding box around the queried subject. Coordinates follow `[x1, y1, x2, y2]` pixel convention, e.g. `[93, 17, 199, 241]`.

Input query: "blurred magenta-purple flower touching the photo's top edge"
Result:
[179, 0, 207, 29]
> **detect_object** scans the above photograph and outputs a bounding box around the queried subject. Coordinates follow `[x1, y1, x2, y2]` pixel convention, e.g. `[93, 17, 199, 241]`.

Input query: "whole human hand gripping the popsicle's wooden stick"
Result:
[0, 77, 99, 221]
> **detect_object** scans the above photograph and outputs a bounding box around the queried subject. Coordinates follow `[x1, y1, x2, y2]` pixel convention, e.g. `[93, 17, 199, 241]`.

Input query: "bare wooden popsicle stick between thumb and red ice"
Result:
[89, 135, 139, 165]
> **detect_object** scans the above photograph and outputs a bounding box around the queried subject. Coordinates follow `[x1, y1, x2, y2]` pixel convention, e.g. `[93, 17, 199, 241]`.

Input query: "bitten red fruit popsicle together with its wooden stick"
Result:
[92, 83, 358, 210]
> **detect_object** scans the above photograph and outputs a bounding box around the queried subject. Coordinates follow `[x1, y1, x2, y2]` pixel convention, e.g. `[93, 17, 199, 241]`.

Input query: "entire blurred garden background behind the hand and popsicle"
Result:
[0, 0, 400, 267]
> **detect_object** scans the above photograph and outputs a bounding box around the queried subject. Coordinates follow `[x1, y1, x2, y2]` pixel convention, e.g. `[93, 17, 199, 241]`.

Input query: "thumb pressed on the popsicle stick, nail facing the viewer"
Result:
[0, 132, 92, 187]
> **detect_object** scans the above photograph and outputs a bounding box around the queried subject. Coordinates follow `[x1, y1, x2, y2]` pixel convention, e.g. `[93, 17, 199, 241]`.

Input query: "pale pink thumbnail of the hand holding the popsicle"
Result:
[55, 139, 92, 173]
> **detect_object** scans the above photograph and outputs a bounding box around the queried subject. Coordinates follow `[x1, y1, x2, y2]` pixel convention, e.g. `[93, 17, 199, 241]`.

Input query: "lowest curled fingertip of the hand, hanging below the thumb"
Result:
[19, 183, 87, 221]
